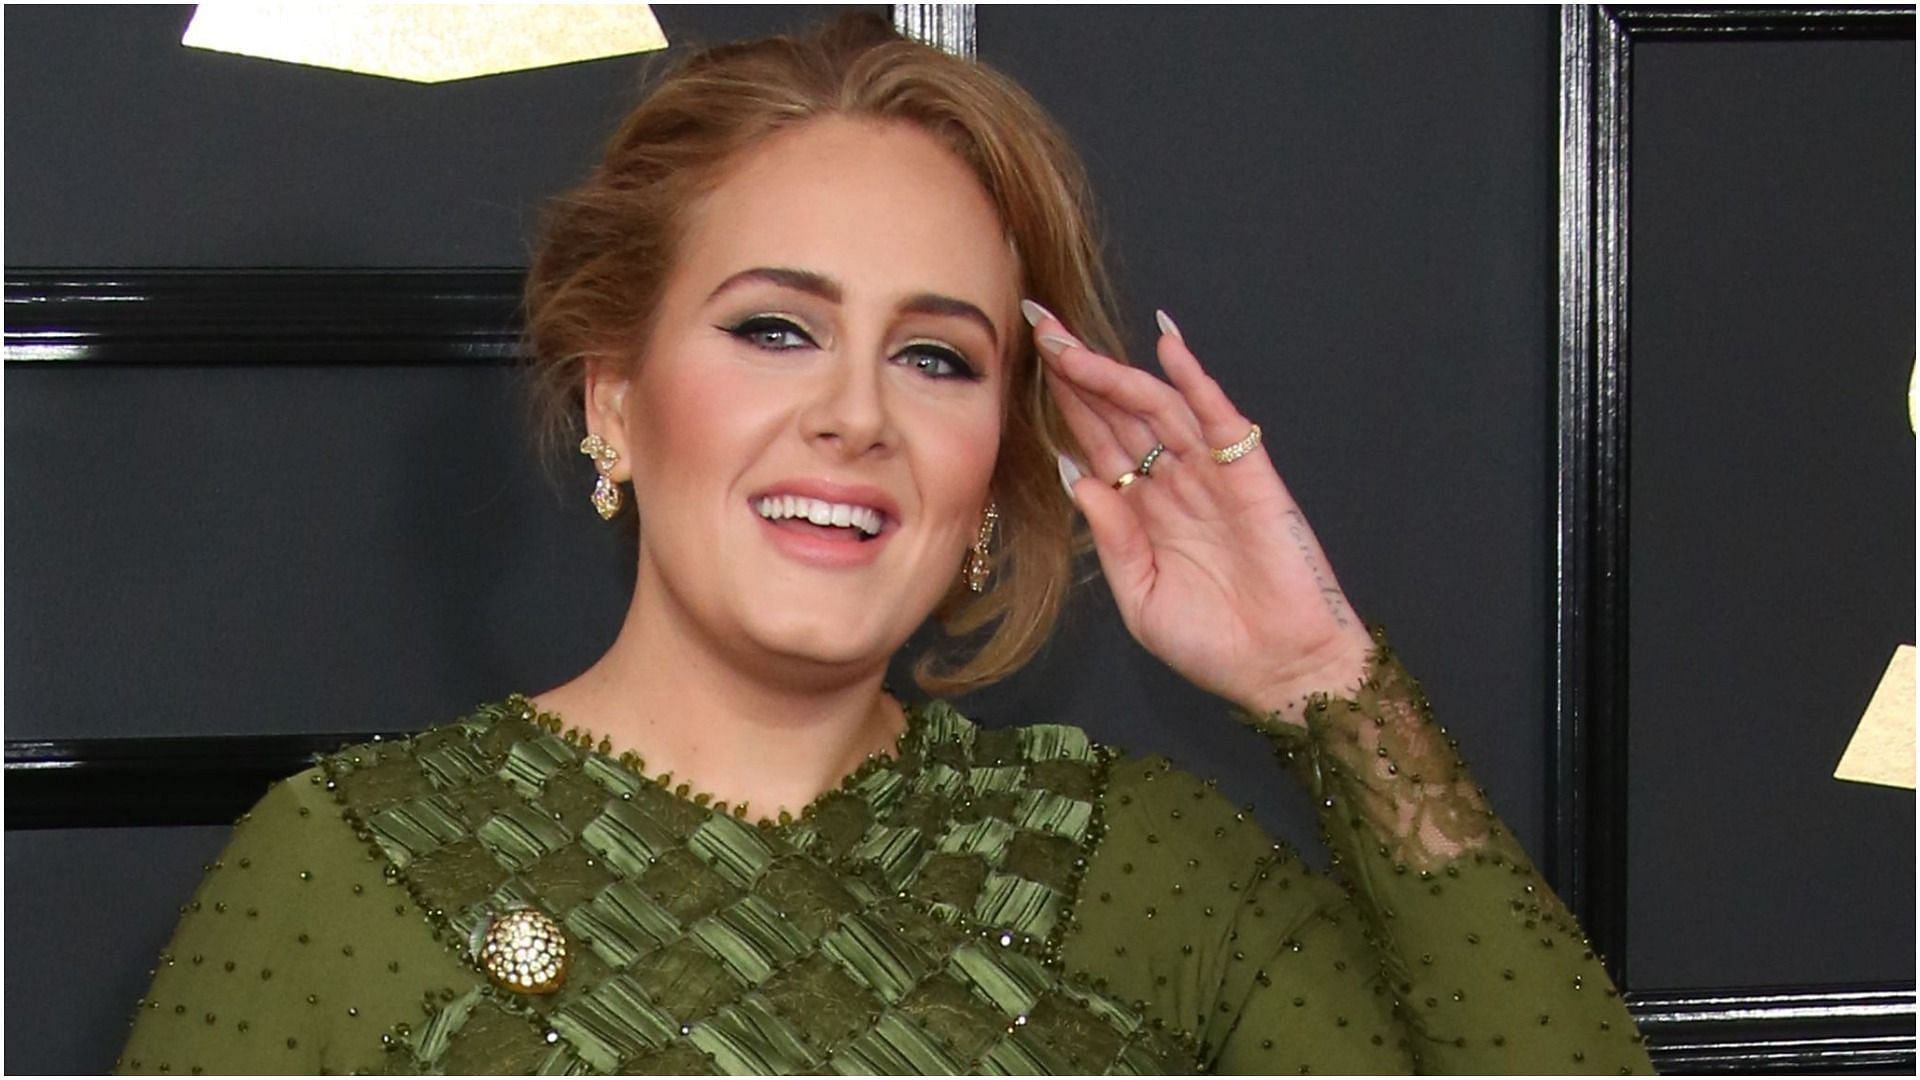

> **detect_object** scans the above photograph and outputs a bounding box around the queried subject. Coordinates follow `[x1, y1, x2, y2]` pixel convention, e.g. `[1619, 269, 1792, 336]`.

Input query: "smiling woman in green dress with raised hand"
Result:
[121, 17, 1647, 1072]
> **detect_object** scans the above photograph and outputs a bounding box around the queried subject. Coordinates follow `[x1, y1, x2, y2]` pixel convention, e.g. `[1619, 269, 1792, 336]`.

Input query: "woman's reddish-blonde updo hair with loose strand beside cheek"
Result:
[526, 15, 1121, 694]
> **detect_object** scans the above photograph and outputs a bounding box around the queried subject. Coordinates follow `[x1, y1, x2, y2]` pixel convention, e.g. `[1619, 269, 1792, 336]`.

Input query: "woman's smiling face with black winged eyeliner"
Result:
[588, 117, 1020, 678]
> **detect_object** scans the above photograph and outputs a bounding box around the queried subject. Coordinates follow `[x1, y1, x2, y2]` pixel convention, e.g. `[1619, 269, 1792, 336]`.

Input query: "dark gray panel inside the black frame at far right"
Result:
[1628, 42, 1914, 988]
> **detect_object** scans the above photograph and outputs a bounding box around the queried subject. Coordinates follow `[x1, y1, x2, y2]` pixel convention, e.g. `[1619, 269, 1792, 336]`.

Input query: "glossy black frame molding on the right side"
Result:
[1546, 4, 1914, 1072]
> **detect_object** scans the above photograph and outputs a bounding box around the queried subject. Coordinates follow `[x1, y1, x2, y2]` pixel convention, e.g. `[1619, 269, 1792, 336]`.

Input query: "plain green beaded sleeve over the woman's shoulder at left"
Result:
[115, 730, 487, 1074]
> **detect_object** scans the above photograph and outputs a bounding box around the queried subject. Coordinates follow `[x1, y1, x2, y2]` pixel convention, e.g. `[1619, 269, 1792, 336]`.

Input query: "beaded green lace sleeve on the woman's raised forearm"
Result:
[1221, 626, 1651, 1072]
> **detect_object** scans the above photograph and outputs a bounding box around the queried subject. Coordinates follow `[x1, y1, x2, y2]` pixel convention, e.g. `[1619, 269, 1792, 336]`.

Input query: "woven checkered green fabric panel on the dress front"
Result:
[324, 698, 1194, 1072]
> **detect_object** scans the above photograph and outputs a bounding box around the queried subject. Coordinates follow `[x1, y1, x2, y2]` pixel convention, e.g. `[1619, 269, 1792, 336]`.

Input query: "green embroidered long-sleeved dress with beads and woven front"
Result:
[117, 630, 1651, 1074]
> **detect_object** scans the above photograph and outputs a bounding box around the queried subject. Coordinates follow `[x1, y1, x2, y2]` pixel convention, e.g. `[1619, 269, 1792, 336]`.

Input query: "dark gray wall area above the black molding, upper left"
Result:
[6, 4, 867, 267]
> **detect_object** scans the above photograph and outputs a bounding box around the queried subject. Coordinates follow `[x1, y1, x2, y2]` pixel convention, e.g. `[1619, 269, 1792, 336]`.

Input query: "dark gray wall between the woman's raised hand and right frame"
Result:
[979, 0, 1557, 876]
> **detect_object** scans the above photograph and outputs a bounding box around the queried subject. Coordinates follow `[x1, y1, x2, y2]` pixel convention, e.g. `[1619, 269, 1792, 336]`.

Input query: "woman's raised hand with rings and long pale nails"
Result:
[1021, 302, 1373, 723]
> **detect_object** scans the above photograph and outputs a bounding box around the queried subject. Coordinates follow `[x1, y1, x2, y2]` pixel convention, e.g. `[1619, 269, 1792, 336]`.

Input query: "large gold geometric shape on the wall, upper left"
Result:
[180, 4, 666, 83]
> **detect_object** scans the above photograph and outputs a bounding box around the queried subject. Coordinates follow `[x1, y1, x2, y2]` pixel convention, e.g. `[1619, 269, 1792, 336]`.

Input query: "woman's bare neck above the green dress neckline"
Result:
[534, 573, 906, 817]
